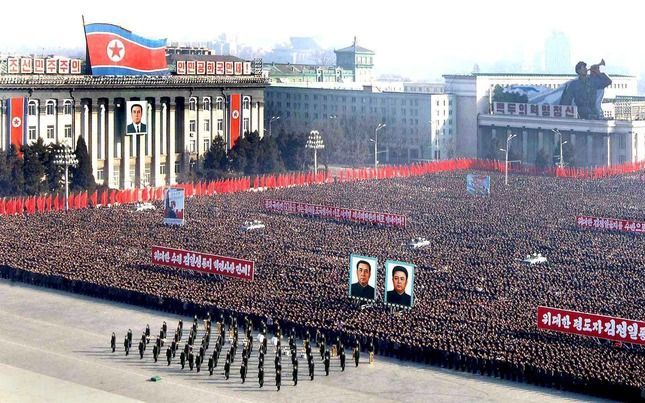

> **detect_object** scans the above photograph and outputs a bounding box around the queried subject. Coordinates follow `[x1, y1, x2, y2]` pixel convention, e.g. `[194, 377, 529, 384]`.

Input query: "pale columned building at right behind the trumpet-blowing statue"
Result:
[444, 73, 645, 167]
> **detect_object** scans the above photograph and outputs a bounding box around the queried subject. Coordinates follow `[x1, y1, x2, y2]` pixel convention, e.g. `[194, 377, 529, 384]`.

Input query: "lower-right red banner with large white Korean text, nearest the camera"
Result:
[537, 306, 645, 345]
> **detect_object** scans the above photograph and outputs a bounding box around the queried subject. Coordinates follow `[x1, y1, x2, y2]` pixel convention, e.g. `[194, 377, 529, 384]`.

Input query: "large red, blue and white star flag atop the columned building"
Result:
[85, 24, 168, 76]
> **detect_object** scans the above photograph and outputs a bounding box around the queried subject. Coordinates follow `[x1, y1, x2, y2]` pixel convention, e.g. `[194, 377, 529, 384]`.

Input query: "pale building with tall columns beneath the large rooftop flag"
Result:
[0, 74, 266, 188]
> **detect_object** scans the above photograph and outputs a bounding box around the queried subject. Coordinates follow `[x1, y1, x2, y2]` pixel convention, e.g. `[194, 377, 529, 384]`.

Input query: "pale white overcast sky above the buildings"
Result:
[0, 0, 645, 79]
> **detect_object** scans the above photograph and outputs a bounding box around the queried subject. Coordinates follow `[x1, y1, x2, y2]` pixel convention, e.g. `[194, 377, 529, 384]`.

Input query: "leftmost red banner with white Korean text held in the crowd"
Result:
[152, 246, 255, 281]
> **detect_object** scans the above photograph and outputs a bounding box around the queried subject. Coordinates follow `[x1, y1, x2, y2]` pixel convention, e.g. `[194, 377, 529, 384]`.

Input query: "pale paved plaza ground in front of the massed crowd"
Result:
[0, 280, 598, 403]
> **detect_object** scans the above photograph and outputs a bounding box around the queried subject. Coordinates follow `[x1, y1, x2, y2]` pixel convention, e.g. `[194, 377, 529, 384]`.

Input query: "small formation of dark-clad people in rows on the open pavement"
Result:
[110, 313, 362, 390]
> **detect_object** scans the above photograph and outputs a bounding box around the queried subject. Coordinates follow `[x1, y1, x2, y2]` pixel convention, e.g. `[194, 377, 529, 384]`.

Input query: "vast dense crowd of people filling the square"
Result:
[0, 172, 645, 399]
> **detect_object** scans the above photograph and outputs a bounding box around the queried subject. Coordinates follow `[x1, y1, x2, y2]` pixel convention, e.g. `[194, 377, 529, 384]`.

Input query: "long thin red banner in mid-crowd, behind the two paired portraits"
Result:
[264, 199, 406, 228]
